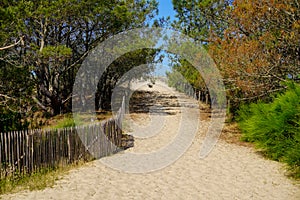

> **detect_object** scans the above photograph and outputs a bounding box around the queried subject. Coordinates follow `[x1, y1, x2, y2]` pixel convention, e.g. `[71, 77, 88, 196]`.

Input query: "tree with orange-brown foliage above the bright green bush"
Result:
[210, 0, 300, 108]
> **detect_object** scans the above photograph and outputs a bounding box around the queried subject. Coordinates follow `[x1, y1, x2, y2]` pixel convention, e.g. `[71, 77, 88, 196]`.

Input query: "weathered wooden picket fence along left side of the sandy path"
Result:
[0, 97, 125, 179]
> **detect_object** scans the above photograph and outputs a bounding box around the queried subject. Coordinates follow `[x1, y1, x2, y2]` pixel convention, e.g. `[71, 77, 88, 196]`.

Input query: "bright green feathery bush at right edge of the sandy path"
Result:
[238, 83, 300, 178]
